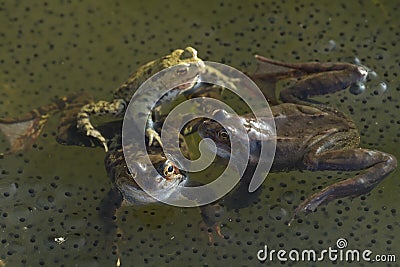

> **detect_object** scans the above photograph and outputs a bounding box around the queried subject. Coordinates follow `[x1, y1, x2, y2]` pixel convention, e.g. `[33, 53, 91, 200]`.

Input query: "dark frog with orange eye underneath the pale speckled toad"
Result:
[101, 131, 221, 238]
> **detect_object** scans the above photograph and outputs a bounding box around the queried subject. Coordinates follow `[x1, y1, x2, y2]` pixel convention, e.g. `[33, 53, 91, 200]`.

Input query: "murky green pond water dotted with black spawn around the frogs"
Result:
[0, 1, 400, 266]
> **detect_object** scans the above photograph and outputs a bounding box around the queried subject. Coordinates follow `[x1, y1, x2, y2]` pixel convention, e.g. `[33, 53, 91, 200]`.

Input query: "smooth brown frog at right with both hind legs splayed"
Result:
[197, 56, 397, 225]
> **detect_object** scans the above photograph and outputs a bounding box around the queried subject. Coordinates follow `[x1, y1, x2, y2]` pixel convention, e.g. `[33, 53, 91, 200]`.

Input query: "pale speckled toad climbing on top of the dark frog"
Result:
[77, 47, 204, 151]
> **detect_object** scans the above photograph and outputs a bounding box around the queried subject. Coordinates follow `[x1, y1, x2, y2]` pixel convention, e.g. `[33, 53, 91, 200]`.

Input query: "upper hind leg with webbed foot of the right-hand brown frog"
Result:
[256, 56, 368, 104]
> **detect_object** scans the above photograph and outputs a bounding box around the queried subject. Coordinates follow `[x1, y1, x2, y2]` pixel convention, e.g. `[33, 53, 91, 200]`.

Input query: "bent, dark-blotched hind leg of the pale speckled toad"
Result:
[77, 99, 126, 152]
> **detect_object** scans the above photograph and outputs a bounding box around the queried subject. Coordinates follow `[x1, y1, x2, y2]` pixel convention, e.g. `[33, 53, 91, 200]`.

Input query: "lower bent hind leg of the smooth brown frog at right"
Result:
[292, 148, 397, 225]
